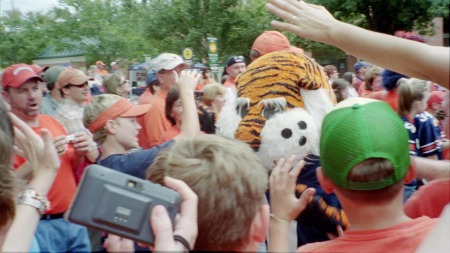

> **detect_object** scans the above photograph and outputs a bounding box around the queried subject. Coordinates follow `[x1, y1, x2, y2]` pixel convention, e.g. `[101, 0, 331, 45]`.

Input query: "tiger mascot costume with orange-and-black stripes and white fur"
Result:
[216, 51, 348, 246]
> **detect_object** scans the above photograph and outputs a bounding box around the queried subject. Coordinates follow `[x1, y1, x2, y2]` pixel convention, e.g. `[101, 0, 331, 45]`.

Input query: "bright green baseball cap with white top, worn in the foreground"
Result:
[320, 97, 410, 191]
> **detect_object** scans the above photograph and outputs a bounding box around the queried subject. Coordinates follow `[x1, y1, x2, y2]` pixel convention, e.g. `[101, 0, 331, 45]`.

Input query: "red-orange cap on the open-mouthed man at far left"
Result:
[2, 63, 44, 89]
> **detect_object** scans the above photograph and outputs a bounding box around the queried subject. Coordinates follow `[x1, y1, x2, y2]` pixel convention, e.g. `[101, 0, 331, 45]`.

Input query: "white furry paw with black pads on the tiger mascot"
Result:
[257, 108, 319, 168]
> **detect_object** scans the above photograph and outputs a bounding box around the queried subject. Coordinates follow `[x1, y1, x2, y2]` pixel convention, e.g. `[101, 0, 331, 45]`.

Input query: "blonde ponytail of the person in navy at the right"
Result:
[397, 78, 430, 116]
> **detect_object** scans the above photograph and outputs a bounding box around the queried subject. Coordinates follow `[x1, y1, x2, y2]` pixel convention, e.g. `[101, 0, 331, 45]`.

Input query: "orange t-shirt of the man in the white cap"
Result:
[138, 90, 172, 149]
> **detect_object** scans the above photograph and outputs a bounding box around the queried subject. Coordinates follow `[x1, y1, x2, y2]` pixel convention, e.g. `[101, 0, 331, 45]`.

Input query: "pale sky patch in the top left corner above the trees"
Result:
[0, 0, 58, 13]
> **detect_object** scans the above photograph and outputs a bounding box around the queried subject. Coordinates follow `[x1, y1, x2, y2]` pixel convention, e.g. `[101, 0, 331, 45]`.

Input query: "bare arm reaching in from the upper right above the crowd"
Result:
[266, 0, 450, 88]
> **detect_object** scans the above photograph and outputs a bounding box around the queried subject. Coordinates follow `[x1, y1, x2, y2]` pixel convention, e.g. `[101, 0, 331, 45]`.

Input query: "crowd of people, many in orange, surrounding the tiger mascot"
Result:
[0, 0, 450, 252]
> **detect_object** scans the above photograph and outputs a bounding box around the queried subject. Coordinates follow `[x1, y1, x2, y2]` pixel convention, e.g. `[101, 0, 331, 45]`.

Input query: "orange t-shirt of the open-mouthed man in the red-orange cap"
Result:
[14, 114, 76, 214]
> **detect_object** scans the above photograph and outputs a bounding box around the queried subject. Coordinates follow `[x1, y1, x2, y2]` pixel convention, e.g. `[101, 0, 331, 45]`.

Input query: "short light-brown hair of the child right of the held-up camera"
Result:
[147, 134, 268, 251]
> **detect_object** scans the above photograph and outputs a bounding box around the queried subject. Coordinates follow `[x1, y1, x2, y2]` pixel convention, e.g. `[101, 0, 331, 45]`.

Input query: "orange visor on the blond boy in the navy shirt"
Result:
[88, 98, 152, 133]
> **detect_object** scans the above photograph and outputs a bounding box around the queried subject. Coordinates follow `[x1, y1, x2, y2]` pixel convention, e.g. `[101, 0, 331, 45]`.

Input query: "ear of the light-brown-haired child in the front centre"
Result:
[250, 204, 270, 243]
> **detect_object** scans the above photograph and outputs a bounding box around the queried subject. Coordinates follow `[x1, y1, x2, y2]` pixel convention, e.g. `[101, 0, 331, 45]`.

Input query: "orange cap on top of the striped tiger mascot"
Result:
[252, 31, 303, 56]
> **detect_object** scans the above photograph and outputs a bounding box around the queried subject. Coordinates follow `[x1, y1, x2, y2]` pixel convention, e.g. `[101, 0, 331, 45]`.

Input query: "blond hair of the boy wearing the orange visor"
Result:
[83, 94, 121, 144]
